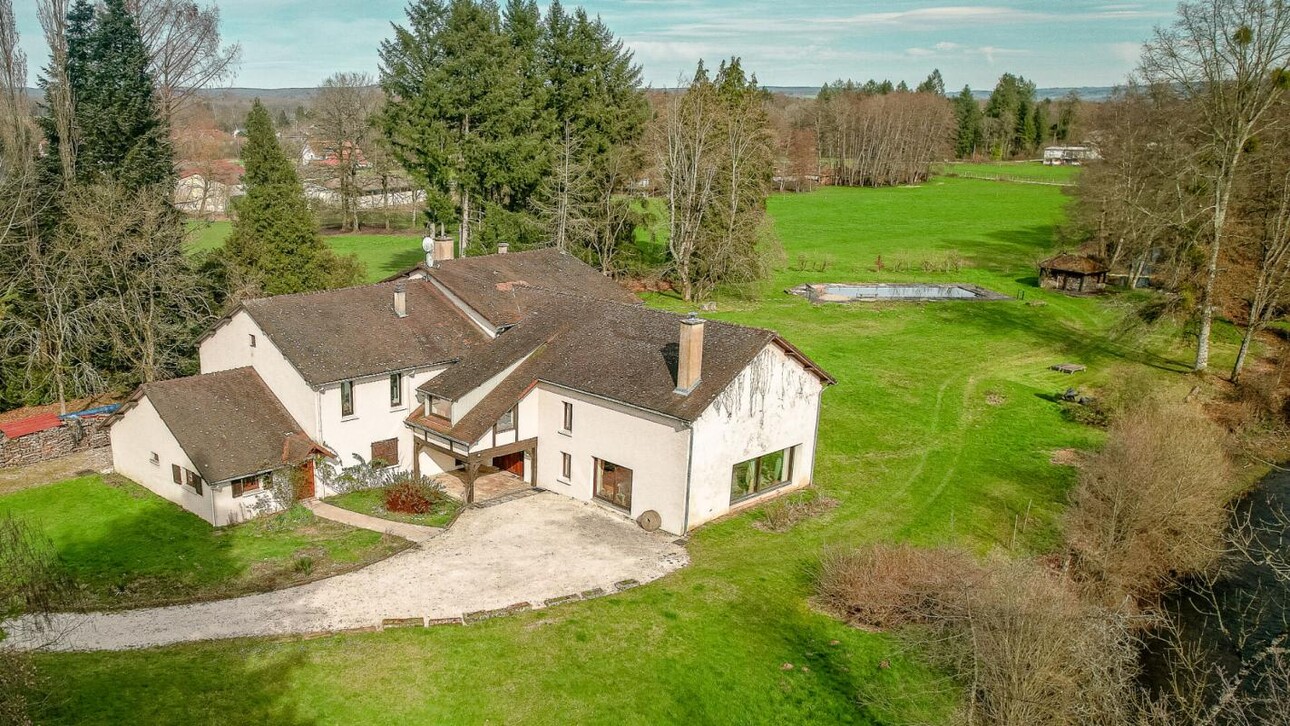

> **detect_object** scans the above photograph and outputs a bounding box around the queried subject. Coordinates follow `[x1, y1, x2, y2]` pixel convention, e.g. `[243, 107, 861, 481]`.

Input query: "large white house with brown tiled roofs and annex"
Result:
[111, 239, 833, 534]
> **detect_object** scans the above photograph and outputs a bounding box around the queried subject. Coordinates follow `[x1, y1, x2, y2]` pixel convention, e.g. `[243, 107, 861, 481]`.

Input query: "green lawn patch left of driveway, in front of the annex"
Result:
[0, 475, 406, 610]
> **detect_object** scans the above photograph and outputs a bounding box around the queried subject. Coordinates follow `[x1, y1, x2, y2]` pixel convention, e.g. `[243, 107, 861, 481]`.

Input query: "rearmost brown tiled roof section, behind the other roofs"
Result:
[428, 248, 640, 328]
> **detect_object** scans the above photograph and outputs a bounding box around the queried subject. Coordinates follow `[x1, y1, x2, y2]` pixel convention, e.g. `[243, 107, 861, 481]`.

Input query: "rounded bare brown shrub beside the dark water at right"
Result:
[1066, 402, 1235, 602]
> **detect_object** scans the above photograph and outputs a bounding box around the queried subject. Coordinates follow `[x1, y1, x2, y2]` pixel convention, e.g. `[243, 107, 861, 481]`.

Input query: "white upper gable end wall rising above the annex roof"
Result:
[197, 311, 319, 438]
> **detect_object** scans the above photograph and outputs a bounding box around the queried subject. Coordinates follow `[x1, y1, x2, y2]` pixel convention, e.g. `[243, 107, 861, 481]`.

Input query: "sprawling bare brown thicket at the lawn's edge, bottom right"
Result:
[818, 544, 1136, 725]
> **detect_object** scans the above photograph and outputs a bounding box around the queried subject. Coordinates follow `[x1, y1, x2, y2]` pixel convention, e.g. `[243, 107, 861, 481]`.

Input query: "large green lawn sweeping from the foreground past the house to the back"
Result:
[37, 179, 1231, 726]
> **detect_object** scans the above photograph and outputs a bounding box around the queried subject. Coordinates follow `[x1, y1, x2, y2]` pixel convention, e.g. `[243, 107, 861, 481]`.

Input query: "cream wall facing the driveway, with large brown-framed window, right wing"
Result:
[534, 384, 690, 533]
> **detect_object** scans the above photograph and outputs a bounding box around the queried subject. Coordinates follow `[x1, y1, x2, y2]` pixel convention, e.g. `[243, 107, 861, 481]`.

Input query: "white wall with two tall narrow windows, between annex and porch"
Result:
[315, 366, 444, 471]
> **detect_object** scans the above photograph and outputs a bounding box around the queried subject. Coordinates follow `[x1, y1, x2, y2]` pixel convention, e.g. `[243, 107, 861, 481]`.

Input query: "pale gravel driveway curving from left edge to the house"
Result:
[3, 493, 689, 650]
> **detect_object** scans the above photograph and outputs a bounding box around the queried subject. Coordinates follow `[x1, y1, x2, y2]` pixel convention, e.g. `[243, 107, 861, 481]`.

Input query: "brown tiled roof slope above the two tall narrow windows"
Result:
[243, 280, 488, 386]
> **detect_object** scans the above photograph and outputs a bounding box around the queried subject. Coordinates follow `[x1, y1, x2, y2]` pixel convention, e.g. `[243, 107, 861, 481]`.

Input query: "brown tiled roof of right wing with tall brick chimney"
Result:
[409, 290, 832, 442]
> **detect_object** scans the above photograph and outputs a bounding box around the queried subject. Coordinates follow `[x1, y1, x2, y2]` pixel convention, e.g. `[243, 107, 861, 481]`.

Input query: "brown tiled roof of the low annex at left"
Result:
[137, 368, 321, 482]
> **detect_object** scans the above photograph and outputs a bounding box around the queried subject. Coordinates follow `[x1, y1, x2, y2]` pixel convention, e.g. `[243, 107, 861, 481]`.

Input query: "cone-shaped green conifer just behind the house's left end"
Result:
[224, 98, 362, 295]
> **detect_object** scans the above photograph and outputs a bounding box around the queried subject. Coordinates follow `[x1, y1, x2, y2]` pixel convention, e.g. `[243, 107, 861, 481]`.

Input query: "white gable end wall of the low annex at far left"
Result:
[108, 396, 219, 524]
